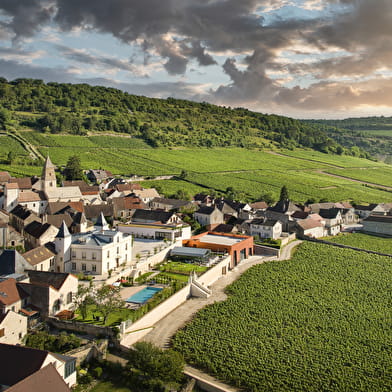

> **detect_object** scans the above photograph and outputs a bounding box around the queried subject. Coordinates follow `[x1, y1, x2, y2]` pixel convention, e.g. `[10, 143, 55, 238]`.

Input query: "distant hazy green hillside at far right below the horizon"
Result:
[306, 116, 392, 163]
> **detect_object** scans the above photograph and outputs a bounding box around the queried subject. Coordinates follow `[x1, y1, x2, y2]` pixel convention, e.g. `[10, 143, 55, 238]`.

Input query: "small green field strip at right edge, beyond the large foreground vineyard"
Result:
[327, 233, 392, 255]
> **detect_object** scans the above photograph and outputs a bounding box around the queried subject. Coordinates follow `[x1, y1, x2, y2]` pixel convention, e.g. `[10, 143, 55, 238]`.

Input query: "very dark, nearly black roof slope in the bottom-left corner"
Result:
[0, 343, 48, 385]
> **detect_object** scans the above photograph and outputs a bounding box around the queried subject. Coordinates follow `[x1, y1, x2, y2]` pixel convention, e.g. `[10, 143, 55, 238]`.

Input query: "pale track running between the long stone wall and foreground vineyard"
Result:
[142, 241, 301, 348]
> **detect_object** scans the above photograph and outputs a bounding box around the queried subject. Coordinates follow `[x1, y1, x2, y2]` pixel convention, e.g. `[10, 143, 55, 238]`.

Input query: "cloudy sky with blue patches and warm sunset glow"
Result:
[0, 0, 392, 118]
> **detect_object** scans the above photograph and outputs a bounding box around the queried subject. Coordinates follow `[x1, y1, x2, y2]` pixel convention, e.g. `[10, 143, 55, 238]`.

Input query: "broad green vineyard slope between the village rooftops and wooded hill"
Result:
[0, 131, 392, 203]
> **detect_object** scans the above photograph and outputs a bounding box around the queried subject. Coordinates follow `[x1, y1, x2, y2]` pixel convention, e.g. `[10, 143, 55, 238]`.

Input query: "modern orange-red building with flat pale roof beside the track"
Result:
[182, 231, 253, 268]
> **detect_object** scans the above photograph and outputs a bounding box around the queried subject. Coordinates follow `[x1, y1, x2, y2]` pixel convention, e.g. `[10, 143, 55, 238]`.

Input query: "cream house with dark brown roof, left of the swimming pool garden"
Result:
[17, 270, 78, 318]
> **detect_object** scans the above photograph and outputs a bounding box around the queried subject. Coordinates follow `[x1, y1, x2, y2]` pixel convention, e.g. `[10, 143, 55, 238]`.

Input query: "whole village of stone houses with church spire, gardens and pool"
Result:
[0, 156, 392, 392]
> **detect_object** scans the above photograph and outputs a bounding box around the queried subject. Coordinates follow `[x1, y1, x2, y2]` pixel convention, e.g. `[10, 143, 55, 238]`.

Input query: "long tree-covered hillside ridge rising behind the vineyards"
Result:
[0, 78, 366, 157]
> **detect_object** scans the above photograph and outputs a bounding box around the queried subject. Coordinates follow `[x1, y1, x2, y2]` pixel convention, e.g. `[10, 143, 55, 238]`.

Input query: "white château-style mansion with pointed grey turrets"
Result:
[54, 215, 132, 275]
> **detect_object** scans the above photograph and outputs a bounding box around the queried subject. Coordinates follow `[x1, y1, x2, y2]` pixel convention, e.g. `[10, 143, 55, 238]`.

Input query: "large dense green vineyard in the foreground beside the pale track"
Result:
[173, 243, 392, 392]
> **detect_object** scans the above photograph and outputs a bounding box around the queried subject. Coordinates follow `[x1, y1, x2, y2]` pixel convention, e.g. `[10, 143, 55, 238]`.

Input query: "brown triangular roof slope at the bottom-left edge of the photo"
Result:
[7, 363, 71, 392]
